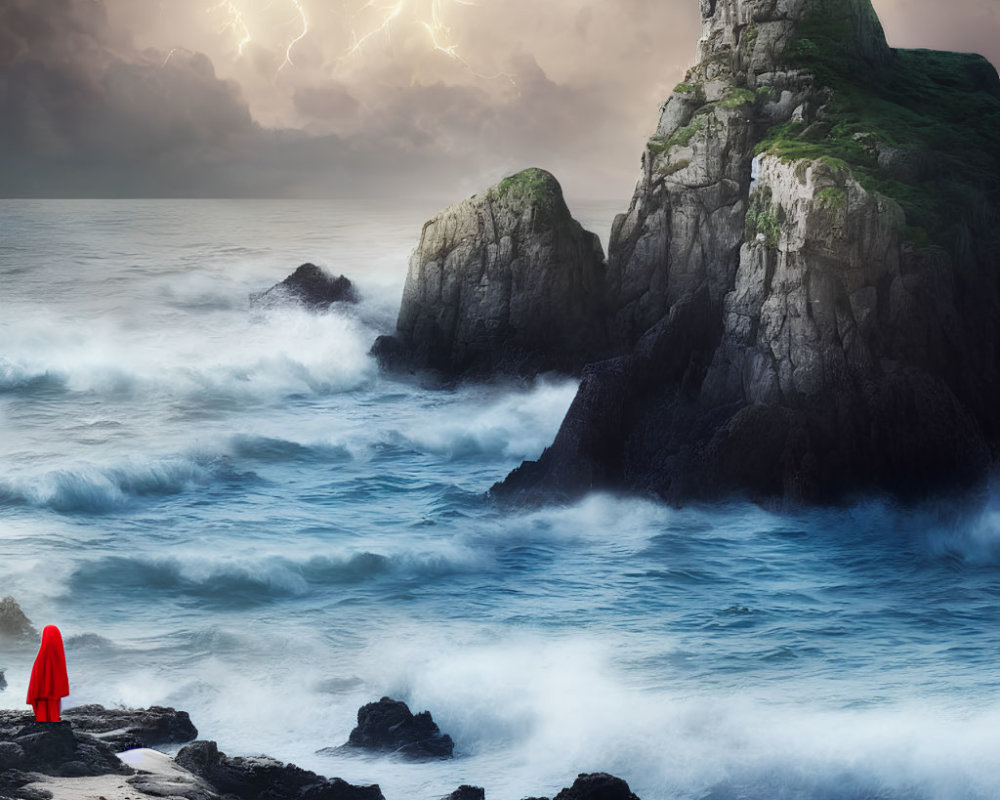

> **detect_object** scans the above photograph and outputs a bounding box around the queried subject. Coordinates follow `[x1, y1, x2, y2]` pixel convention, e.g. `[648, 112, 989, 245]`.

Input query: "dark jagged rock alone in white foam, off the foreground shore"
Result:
[344, 697, 455, 760]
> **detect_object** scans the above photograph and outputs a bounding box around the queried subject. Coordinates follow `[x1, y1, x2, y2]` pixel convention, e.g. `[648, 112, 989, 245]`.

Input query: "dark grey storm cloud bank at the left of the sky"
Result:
[0, 0, 258, 195]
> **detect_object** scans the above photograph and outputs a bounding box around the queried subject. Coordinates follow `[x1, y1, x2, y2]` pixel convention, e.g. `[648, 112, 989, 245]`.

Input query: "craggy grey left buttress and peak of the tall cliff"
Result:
[609, 0, 890, 345]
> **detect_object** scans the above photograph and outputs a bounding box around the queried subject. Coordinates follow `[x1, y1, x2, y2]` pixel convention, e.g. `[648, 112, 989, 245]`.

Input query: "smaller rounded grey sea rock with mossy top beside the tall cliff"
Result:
[373, 169, 607, 377]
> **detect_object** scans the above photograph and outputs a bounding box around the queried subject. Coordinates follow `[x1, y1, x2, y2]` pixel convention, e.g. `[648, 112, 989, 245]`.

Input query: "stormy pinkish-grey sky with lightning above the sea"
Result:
[0, 0, 1000, 202]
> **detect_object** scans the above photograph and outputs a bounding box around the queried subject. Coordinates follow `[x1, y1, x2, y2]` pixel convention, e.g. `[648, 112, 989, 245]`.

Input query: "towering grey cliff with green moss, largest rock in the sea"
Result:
[495, 0, 1000, 502]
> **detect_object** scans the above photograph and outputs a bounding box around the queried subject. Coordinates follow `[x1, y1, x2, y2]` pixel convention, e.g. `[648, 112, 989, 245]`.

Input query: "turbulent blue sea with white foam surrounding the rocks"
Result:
[0, 201, 1000, 800]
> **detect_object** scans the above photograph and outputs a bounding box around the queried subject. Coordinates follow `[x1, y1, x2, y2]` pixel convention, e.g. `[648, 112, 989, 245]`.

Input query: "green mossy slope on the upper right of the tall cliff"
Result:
[757, 3, 1000, 253]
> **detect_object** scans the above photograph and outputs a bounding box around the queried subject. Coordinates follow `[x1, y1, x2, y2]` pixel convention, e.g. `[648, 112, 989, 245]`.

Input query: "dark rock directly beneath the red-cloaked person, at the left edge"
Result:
[0, 711, 132, 789]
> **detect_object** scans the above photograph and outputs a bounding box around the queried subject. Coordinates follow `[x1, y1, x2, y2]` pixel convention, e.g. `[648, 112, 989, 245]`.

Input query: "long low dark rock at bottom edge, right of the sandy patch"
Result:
[175, 741, 384, 800]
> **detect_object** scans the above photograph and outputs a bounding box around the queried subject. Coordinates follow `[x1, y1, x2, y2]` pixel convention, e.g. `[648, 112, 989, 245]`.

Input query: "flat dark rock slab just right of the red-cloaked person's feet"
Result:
[62, 705, 198, 751]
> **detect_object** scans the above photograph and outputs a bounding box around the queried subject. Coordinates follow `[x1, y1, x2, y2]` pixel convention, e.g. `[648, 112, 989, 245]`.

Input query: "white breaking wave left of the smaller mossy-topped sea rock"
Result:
[0, 309, 374, 402]
